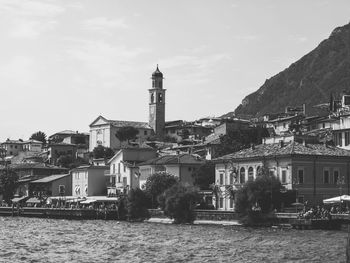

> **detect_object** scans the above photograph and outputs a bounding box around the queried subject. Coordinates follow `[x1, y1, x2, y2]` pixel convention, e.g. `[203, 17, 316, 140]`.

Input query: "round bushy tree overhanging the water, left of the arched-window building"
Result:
[158, 183, 199, 224]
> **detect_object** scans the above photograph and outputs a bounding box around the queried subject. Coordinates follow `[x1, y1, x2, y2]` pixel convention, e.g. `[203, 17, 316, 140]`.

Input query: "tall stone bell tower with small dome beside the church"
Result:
[148, 65, 165, 137]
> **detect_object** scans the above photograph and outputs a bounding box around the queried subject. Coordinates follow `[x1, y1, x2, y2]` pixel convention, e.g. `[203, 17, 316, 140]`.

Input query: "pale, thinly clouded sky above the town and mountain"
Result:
[0, 0, 350, 142]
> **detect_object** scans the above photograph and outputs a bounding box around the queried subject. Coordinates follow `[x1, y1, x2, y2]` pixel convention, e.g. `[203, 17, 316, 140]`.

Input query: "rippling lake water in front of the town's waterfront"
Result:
[0, 217, 347, 262]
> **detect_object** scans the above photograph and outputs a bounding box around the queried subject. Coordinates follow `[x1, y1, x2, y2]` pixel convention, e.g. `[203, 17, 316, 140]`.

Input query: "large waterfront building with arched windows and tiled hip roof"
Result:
[214, 141, 350, 210]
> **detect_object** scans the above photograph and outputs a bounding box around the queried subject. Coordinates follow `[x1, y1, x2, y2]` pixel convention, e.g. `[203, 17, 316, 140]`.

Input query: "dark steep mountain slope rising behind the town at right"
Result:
[235, 24, 350, 116]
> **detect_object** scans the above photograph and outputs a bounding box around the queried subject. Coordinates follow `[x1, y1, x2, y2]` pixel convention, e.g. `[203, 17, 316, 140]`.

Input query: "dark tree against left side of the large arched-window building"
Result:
[192, 162, 215, 190]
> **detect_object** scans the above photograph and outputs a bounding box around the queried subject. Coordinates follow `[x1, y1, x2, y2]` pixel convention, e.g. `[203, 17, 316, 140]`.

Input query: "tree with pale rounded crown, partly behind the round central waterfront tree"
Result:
[144, 172, 178, 208]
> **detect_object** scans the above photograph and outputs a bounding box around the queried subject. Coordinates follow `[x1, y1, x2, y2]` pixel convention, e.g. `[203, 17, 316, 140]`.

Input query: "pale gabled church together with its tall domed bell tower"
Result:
[89, 65, 166, 152]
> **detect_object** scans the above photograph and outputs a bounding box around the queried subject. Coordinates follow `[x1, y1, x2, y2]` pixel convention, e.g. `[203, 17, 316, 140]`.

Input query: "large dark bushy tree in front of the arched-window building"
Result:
[235, 174, 282, 224]
